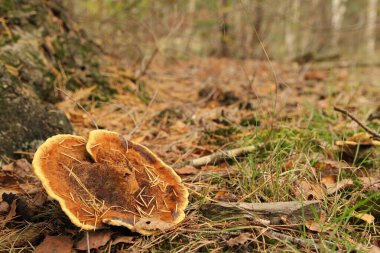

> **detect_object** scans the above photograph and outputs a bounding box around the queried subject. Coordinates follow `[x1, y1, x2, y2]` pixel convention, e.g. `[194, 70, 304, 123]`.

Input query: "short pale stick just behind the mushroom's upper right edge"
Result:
[172, 145, 261, 169]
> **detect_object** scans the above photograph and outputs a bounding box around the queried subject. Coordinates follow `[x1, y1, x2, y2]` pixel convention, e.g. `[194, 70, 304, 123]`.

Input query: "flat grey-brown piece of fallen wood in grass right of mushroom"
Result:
[201, 200, 321, 225]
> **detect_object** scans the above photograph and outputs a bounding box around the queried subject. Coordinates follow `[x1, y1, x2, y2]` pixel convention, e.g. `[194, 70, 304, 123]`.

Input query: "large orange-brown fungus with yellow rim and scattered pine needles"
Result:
[33, 130, 188, 235]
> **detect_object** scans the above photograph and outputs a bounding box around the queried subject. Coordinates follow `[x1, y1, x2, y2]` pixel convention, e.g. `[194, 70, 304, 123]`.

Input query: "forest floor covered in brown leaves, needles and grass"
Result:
[0, 58, 380, 252]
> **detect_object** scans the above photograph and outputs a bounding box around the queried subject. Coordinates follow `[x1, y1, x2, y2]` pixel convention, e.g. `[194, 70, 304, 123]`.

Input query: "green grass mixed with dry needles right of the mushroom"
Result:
[127, 115, 380, 252]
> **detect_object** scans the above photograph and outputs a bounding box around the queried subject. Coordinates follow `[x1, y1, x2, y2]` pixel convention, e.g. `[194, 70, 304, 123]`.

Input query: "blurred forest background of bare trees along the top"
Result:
[65, 0, 380, 64]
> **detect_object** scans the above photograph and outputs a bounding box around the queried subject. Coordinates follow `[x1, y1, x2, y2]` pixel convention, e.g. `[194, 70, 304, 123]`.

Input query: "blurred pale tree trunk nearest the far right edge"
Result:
[365, 0, 378, 55]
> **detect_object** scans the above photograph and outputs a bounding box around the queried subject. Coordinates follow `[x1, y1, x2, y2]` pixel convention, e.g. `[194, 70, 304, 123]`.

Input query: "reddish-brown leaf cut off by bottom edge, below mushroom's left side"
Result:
[34, 235, 73, 253]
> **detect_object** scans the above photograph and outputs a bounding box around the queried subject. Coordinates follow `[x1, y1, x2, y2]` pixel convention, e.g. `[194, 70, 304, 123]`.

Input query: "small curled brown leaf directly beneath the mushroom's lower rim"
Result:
[75, 230, 112, 250]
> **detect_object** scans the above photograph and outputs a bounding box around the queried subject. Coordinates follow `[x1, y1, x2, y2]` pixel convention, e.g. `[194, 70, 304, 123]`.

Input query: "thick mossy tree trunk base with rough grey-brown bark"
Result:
[0, 0, 111, 160]
